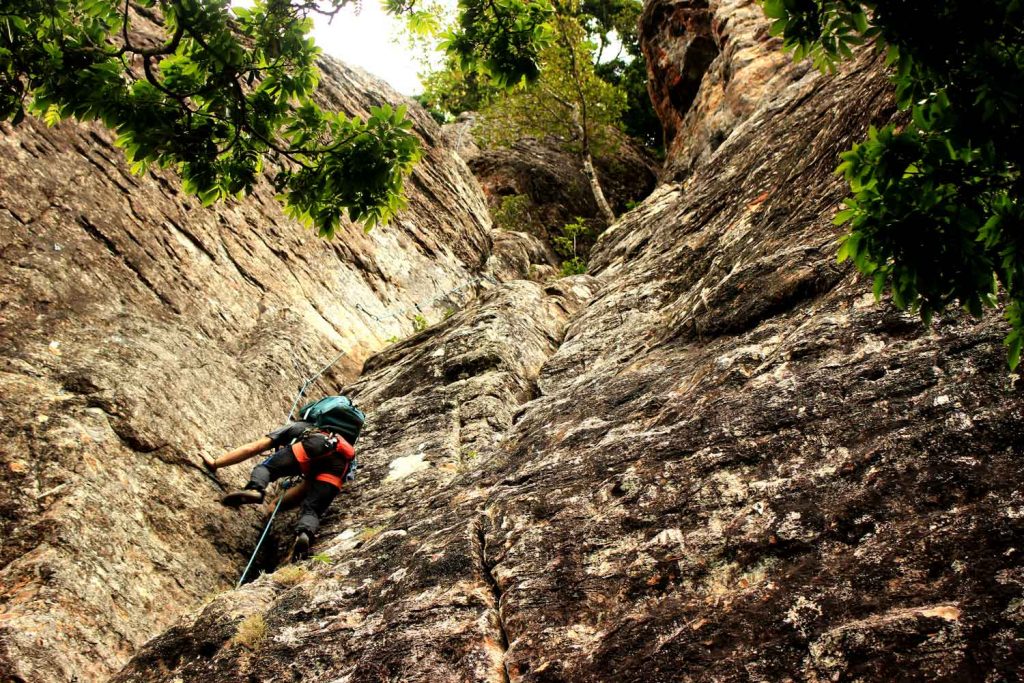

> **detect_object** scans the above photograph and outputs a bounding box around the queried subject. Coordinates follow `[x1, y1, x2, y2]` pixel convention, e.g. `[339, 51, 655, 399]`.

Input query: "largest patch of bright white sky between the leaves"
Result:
[305, 0, 446, 95]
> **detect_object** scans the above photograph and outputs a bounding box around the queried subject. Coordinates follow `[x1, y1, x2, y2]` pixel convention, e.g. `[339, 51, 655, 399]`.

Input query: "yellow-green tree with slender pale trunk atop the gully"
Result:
[421, 0, 660, 223]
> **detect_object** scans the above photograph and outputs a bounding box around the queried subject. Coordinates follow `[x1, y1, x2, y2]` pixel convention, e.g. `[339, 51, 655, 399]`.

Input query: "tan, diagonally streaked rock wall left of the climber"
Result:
[0, 61, 489, 681]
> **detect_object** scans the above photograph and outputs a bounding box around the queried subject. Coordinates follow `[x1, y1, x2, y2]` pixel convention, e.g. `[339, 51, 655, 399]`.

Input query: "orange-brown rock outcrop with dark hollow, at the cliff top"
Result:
[640, 0, 809, 180]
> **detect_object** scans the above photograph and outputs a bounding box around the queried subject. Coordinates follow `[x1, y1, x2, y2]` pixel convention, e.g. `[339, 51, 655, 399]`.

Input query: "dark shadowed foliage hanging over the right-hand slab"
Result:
[764, 0, 1024, 369]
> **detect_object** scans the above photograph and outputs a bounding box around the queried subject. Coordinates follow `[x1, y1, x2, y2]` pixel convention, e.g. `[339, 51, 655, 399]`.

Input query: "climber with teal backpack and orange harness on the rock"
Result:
[203, 396, 365, 559]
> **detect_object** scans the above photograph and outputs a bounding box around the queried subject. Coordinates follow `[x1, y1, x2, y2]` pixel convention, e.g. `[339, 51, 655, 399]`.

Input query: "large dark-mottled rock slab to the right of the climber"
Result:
[117, 37, 1024, 683]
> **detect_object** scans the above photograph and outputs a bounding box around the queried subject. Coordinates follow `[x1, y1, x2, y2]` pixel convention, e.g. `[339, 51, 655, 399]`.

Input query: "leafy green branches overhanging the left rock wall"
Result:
[0, 0, 420, 237]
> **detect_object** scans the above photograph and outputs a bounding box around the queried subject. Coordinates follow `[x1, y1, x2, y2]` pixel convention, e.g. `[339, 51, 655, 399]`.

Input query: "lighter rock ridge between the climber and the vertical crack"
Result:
[115, 276, 595, 682]
